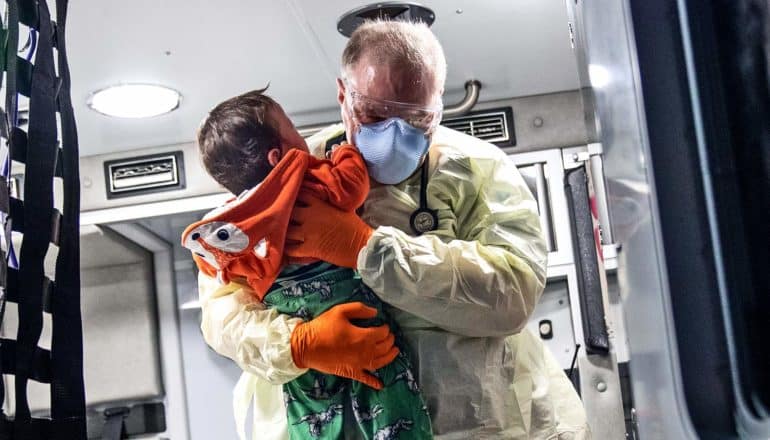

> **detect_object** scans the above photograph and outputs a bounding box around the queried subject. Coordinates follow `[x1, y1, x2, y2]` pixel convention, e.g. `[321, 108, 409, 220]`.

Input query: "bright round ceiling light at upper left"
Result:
[88, 84, 182, 118]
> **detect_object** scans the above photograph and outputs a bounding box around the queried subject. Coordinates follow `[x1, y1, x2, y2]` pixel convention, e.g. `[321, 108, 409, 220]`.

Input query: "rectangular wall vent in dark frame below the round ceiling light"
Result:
[104, 151, 185, 199]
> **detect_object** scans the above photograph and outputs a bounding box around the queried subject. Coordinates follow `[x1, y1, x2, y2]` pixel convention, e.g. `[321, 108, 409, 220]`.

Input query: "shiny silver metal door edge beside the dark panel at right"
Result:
[566, 0, 697, 439]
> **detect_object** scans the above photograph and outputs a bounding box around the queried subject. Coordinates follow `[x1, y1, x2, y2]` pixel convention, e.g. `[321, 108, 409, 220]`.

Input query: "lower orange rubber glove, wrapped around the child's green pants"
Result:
[291, 302, 398, 390]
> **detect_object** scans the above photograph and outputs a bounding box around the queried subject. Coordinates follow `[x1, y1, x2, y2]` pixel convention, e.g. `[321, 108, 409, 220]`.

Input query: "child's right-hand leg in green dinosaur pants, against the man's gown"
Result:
[350, 352, 433, 440]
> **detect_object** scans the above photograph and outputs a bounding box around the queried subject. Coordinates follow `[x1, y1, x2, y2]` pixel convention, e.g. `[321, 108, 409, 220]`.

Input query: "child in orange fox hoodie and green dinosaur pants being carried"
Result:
[182, 89, 432, 440]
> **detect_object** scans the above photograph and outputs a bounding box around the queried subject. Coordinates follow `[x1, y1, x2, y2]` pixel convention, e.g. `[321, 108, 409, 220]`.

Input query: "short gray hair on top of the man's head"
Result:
[342, 20, 446, 97]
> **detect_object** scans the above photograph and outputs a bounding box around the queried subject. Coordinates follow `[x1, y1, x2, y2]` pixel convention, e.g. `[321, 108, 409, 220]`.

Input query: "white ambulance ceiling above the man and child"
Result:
[67, 0, 579, 156]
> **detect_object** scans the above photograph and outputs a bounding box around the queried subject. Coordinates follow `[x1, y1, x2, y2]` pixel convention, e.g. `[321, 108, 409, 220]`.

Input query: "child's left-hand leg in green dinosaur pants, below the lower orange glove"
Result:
[283, 370, 348, 440]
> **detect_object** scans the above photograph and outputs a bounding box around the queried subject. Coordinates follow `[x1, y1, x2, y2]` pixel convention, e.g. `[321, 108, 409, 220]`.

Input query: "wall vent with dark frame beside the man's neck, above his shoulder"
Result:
[441, 107, 516, 147]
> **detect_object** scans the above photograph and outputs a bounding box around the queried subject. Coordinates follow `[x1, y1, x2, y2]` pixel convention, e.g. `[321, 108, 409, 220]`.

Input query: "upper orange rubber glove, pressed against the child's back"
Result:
[284, 193, 374, 269]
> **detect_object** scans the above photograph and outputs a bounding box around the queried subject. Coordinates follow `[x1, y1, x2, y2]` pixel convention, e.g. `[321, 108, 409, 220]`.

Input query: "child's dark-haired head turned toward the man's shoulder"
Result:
[198, 88, 307, 195]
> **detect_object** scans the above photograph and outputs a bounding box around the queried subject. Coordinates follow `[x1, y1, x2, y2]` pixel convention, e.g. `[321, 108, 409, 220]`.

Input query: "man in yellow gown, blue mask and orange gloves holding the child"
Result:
[201, 18, 590, 440]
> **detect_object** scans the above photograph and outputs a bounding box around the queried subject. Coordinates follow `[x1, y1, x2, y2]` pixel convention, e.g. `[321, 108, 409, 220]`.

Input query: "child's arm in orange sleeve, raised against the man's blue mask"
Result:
[303, 145, 369, 211]
